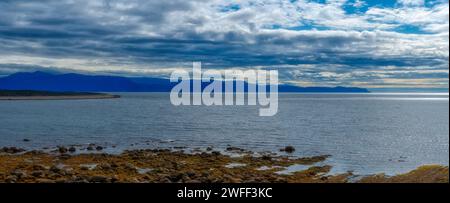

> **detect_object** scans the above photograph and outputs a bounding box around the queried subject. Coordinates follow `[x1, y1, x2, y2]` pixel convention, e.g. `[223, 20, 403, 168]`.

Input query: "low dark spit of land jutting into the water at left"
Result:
[0, 90, 120, 100]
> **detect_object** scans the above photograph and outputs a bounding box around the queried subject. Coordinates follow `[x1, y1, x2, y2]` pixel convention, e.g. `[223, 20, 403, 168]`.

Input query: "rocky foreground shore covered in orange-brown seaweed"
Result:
[0, 145, 449, 183]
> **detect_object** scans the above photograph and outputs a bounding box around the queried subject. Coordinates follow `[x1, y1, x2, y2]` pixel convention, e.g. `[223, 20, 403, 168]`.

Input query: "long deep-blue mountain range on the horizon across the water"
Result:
[0, 71, 369, 93]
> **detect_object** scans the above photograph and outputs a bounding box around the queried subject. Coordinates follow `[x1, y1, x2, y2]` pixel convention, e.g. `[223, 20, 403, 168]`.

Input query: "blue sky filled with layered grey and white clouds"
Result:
[0, 0, 449, 88]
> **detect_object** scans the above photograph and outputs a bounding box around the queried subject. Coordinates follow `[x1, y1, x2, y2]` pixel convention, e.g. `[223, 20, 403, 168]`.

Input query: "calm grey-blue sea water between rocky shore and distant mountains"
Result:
[0, 93, 449, 175]
